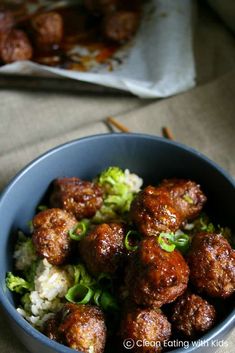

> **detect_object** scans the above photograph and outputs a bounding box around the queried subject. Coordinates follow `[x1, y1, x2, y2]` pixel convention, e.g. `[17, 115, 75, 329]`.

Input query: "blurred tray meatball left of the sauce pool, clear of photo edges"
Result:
[31, 12, 64, 48]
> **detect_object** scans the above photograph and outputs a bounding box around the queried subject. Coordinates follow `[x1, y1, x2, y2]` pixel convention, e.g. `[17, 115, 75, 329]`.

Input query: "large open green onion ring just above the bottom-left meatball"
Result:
[65, 284, 94, 304]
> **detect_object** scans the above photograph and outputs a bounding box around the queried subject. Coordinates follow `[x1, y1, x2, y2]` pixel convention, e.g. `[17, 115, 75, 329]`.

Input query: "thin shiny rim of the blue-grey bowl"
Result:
[0, 133, 235, 353]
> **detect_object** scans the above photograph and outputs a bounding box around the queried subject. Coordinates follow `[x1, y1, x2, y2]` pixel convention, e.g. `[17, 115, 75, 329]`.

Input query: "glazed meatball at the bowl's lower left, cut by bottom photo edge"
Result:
[44, 303, 106, 353]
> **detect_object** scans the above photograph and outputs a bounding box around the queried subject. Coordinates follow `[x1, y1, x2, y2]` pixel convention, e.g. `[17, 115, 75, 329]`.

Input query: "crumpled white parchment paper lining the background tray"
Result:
[0, 0, 195, 98]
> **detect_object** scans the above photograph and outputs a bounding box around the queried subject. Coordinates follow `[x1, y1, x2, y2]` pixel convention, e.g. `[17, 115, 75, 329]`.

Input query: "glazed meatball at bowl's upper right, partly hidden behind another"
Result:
[158, 179, 206, 220]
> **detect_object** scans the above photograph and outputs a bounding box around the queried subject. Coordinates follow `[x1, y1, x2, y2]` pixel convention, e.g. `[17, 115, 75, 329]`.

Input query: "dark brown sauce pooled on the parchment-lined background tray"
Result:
[0, 0, 141, 71]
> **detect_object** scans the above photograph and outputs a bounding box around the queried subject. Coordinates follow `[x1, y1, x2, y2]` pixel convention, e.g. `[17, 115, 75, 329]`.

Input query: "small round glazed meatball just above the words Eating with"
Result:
[171, 293, 216, 338]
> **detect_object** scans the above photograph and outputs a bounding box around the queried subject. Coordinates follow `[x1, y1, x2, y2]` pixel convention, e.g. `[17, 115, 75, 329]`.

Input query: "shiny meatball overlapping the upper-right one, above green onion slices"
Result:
[130, 186, 182, 236]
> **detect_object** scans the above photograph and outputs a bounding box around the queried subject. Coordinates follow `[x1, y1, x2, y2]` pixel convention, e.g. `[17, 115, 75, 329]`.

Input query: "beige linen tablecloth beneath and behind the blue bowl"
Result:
[0, 71, 235, 353]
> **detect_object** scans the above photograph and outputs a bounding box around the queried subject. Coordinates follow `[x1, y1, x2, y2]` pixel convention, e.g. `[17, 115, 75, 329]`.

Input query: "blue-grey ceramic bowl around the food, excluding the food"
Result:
[0, 134, 235, 353]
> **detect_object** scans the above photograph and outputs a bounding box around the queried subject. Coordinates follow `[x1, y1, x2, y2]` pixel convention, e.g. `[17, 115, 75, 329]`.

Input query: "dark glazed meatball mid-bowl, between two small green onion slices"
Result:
[79, 223, 125, 275]
